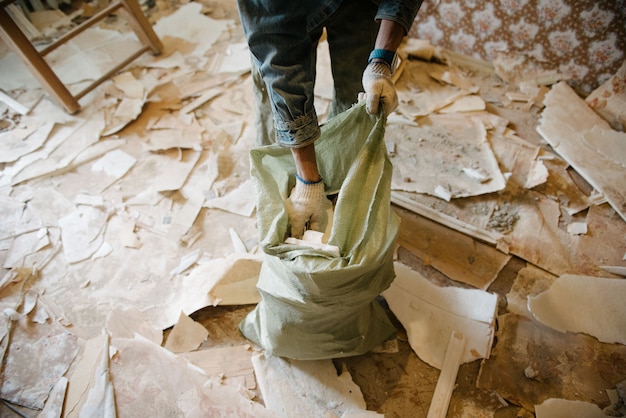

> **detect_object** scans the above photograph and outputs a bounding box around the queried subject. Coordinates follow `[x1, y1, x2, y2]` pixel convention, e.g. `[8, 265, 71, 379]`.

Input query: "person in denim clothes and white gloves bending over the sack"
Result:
[237, 0, 422, 238]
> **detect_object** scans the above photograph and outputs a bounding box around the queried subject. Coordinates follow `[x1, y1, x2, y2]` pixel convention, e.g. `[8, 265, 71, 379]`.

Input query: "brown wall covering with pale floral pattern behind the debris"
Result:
[409, 0, 626, 93]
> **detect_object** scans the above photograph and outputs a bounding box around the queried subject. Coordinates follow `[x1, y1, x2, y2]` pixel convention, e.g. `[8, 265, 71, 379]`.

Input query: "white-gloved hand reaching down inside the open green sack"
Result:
[286, 176, 331, 239]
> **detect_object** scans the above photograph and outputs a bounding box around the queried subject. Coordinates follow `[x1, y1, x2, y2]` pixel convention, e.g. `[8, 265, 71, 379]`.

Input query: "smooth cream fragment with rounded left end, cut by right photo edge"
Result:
[528, 274, 626, 344]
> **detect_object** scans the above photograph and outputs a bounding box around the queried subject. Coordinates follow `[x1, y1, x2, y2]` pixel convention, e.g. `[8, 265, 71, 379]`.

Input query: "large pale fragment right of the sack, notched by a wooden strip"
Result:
[383, 263, 498, 369]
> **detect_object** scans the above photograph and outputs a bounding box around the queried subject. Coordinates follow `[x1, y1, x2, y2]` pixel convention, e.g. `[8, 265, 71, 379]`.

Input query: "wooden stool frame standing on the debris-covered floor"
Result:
[0, 0, 163, 113]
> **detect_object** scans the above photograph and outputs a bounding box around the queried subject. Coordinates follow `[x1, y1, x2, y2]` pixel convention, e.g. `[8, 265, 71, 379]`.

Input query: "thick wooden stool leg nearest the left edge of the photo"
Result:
[0, 7, 80, 113]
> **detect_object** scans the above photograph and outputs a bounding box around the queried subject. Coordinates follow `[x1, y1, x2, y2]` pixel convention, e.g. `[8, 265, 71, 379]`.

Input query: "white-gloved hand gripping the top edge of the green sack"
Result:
[362, 61, 398, 116]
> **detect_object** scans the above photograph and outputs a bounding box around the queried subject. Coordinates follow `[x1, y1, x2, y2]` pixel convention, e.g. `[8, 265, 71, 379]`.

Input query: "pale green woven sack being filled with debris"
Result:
[239, 103, 400, 360]
